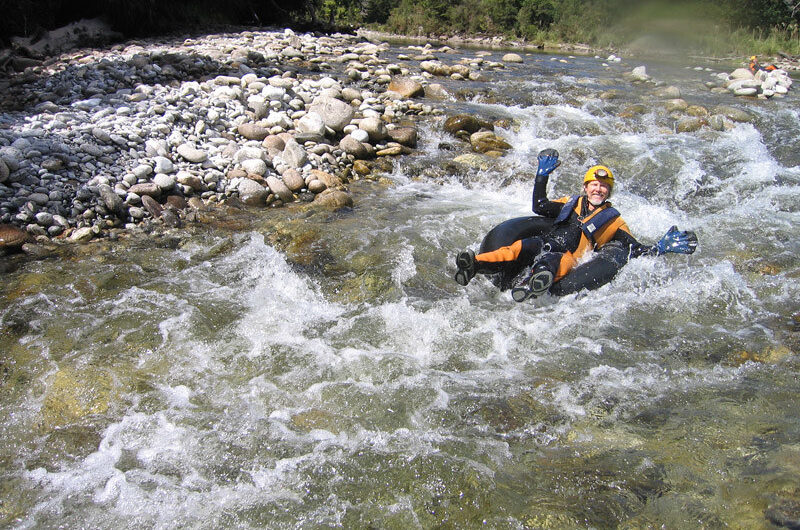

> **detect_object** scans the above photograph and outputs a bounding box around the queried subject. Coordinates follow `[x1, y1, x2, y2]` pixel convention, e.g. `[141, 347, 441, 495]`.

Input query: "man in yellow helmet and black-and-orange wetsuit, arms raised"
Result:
[455, 149, 697, 302]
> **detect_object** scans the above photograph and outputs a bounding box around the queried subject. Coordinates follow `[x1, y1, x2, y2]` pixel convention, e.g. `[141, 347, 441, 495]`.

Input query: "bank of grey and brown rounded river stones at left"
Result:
[0, 29, 462, 254]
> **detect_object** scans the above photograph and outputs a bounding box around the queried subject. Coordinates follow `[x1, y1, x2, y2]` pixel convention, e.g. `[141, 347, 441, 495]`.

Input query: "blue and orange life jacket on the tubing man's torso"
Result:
[554, 195, 629, 280]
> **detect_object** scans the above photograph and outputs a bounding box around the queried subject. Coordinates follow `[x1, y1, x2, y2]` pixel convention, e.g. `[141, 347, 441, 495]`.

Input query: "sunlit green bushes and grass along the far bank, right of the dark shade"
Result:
[376, 0, 800, 55]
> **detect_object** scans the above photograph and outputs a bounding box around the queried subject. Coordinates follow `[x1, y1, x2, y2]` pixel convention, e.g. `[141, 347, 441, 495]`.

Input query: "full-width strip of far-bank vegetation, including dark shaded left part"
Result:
[0, 0, 800, 56]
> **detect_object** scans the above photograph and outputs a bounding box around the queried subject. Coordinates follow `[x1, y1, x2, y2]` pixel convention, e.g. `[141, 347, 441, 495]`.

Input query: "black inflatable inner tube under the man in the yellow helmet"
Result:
[480, 216, 629, 296]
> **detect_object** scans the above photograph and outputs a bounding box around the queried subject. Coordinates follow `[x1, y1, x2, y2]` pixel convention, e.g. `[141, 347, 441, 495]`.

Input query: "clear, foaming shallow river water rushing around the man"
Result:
[0, 47, 800, 528]
